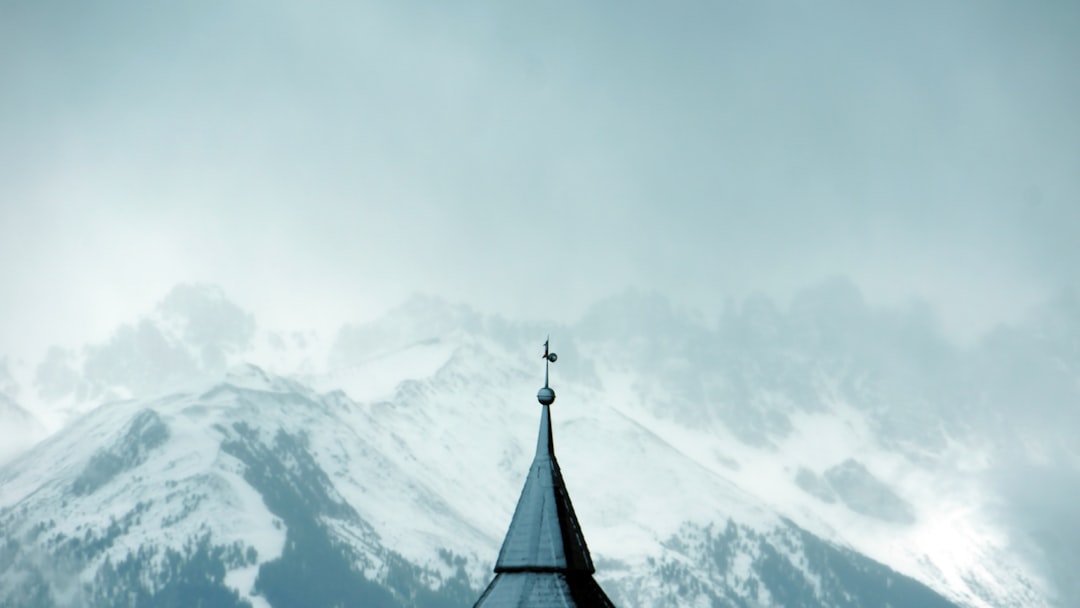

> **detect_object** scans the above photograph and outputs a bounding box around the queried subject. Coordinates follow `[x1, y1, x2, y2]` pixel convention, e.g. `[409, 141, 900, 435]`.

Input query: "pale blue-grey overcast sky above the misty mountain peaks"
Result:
[0, 0, 1080, 353]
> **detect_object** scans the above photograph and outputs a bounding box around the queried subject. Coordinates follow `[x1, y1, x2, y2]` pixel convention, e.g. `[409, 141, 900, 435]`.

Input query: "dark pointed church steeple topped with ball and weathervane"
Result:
[474, 342, 615, 608]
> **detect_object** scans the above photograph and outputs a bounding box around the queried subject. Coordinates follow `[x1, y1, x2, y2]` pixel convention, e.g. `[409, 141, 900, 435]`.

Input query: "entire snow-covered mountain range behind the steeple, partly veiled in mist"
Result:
[0, 284, 1080, 607]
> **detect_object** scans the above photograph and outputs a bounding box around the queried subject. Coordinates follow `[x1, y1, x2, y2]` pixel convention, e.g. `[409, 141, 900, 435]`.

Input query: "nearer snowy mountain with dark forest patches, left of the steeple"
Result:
[0, 366, 972, 606]
